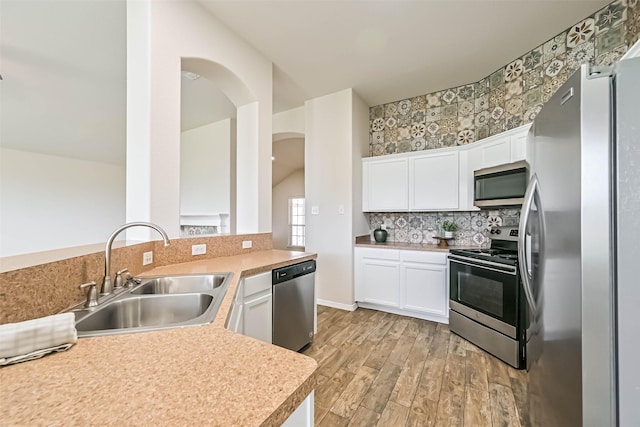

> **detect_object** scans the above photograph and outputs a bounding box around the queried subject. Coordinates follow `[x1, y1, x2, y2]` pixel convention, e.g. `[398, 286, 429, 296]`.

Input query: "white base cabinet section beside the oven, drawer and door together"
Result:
[400, 251, 449, 318]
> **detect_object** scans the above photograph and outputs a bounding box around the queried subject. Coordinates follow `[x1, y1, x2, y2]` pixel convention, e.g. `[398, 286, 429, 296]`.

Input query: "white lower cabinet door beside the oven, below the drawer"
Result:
[402, 262, 449, 317]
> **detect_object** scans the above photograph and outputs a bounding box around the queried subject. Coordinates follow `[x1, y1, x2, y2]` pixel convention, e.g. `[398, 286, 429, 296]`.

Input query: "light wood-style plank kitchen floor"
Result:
[304, 306, 528, 427]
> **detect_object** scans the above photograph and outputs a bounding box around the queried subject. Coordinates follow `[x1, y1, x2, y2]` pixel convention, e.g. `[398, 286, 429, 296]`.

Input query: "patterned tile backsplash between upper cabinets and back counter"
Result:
[369, 209, 520, 247]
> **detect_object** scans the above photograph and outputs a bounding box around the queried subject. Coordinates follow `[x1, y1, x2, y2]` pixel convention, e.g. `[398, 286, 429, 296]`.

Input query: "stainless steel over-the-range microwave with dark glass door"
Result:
[473, 160, 529, 209]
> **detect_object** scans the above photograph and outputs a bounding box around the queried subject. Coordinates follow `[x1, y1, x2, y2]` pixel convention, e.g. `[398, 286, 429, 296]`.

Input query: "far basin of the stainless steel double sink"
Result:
[131, 273, 228, 295]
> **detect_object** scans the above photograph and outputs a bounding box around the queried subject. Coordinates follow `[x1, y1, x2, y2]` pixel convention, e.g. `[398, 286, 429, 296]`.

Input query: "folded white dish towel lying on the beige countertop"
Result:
[0, 313, 78, 366]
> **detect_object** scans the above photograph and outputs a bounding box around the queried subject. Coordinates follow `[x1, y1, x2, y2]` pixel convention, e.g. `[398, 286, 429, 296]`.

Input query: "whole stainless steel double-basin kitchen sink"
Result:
[72, 273, 231, 338]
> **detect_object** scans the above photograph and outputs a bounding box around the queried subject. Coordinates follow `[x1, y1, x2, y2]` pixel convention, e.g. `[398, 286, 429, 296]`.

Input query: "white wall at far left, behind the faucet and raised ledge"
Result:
[0, 148, 125, 257]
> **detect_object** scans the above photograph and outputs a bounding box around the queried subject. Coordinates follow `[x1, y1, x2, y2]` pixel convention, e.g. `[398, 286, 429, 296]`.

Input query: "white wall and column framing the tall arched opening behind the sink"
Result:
[127, 0, 272, 238]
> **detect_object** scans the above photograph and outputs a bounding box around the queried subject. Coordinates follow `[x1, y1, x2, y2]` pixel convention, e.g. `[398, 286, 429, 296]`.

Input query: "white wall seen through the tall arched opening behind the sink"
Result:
[180, 118, 235, 215]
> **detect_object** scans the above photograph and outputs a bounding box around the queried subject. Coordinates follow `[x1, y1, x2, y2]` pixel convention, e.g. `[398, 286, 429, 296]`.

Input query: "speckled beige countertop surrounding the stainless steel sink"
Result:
[0, 250, 317, 426]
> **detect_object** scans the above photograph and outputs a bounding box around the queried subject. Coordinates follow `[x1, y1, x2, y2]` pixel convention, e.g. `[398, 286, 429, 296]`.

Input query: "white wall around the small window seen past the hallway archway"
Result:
[272, 169, 304, 249]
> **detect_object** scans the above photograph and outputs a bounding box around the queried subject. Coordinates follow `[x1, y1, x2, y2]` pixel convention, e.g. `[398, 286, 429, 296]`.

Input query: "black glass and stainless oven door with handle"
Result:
[449, 255, 520, 339]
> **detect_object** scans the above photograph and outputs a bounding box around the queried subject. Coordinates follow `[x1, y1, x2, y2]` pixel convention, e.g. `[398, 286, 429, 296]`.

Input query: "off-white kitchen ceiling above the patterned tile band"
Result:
[198, 0, 610, 113]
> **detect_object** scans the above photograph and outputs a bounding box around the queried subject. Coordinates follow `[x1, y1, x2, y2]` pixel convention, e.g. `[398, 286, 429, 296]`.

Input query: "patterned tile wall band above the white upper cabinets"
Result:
[369, 0, 640, 156]
